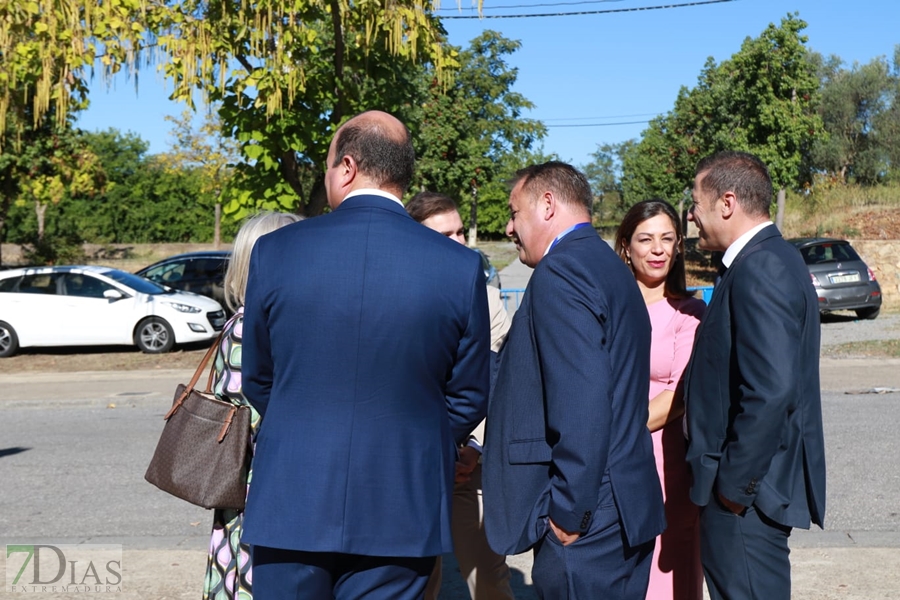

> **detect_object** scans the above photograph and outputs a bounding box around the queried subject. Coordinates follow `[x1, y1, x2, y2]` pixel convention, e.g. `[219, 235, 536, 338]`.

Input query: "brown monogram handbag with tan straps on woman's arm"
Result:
[144, 334, 250, 510]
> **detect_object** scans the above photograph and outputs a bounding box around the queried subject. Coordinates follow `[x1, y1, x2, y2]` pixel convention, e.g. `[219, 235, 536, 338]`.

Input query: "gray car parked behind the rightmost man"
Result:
[789, 238, 881, 319]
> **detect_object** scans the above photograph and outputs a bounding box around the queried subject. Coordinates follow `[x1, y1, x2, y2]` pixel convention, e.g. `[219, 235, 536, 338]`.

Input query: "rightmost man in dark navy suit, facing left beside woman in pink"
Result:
[684, 152, 825, 600]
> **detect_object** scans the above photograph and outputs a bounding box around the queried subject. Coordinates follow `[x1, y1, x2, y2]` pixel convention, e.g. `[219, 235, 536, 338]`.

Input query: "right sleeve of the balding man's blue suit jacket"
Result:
[446, 264, 491, 444]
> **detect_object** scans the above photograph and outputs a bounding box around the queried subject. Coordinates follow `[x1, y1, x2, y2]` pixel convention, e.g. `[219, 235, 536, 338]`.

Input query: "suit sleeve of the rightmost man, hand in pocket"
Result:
[716, 252, 809, 506]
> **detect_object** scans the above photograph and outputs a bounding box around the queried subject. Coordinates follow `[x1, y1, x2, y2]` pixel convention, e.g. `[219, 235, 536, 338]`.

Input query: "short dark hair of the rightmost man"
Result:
[695, 151, 772, 216]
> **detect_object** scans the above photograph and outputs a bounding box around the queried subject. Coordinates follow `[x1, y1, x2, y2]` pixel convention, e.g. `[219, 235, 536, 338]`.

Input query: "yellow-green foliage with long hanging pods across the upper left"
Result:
[0, 0, 464, 149]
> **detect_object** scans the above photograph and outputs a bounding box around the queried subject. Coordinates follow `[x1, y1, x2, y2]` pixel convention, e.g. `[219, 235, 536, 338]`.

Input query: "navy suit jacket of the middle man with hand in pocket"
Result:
[483, 228, 665, 554]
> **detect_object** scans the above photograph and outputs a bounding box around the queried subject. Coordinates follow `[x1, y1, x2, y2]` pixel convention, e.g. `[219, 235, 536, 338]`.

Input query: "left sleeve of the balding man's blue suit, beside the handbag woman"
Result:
[241, 243, 273, 416]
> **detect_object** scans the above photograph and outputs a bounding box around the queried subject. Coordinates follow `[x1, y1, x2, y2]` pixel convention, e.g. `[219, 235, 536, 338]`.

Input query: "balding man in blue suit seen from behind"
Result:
[243, 111, 490, 600]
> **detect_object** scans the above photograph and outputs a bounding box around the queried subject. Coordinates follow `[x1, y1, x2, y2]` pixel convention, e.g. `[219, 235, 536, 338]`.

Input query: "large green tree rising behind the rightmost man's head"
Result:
[623, 14, 825, 209]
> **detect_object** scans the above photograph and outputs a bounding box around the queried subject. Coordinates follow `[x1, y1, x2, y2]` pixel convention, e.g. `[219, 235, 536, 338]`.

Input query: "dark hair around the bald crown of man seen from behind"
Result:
[331, 113, 416, 195]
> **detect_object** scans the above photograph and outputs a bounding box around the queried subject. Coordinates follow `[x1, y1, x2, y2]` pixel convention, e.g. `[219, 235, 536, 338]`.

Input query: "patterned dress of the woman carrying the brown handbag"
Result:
[203, 307, 259, 600]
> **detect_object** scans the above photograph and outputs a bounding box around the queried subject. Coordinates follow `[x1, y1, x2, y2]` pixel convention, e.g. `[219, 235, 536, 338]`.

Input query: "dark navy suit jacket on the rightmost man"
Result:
[685, 226, 825, 528]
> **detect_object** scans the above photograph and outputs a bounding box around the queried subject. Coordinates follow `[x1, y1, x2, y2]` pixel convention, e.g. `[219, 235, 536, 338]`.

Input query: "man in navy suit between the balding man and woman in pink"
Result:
[483, 162, 665, 600]
